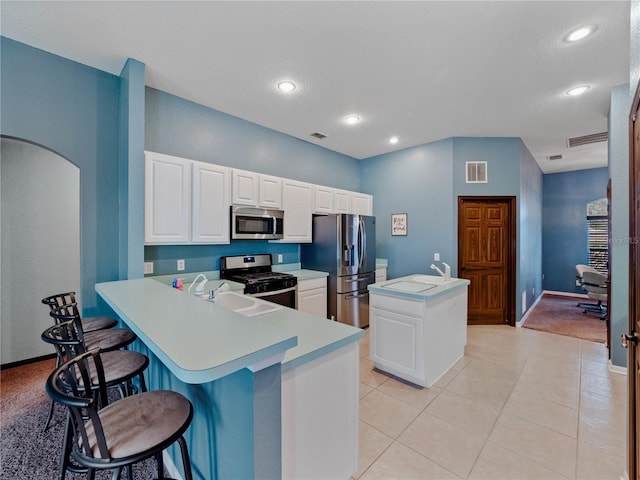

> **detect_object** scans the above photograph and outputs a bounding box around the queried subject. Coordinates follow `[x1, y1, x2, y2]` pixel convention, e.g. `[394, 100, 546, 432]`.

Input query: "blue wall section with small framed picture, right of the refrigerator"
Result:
[360, 139, 457, 278]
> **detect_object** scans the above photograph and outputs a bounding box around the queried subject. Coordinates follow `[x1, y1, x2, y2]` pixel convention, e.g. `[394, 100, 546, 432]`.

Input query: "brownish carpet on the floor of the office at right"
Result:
[522, 294, 607, 343]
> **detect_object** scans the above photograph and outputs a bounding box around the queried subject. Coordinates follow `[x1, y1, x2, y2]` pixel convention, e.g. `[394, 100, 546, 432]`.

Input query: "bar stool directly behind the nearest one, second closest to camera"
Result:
[41, 318, 149, 480]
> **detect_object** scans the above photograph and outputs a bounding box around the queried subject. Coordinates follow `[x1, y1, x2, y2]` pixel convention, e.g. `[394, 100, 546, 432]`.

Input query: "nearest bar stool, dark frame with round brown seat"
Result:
[46, 349, 193, 480]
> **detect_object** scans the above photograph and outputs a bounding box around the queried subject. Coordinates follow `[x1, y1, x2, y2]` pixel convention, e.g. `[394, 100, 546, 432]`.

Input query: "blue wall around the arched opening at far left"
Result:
[0, 37, 119, 314]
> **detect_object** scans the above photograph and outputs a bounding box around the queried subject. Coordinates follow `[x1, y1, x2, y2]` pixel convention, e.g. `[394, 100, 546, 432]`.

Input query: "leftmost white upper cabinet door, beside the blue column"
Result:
[144, 152, 191, 244]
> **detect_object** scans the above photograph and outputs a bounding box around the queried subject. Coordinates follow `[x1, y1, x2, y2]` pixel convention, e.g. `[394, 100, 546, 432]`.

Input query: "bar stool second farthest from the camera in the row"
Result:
[42, 304, 138, 432]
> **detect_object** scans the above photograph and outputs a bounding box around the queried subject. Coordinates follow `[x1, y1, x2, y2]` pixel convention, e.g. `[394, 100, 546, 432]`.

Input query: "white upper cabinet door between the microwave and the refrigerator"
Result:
[281, 179, 313, 243]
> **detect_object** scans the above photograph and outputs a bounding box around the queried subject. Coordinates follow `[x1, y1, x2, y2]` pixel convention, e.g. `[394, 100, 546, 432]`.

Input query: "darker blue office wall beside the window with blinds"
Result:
[542, 168, 609, 293]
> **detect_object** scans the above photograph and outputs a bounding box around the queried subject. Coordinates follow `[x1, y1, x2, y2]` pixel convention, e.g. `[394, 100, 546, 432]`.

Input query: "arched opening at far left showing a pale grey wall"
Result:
[0, 137, 80, 366]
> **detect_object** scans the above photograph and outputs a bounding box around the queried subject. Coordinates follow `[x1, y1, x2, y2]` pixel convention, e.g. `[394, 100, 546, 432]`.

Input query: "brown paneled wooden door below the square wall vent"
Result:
[458, 197, 515, 325]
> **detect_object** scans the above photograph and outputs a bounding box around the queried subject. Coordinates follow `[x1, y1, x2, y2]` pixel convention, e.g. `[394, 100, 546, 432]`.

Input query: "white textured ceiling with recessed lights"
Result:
[0, 0, 630, 173]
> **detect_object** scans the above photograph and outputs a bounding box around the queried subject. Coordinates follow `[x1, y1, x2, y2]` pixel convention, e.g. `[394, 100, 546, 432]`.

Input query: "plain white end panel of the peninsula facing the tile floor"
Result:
[282, 341, 359, 480]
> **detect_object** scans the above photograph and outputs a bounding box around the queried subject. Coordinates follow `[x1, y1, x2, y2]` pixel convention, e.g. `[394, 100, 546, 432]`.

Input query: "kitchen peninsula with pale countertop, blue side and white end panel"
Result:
[96, 278, 364, 480]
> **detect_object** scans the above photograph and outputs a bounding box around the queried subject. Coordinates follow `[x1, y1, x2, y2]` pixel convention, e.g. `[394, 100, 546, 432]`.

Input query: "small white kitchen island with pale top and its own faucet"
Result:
[369, 275, 470, 387]
